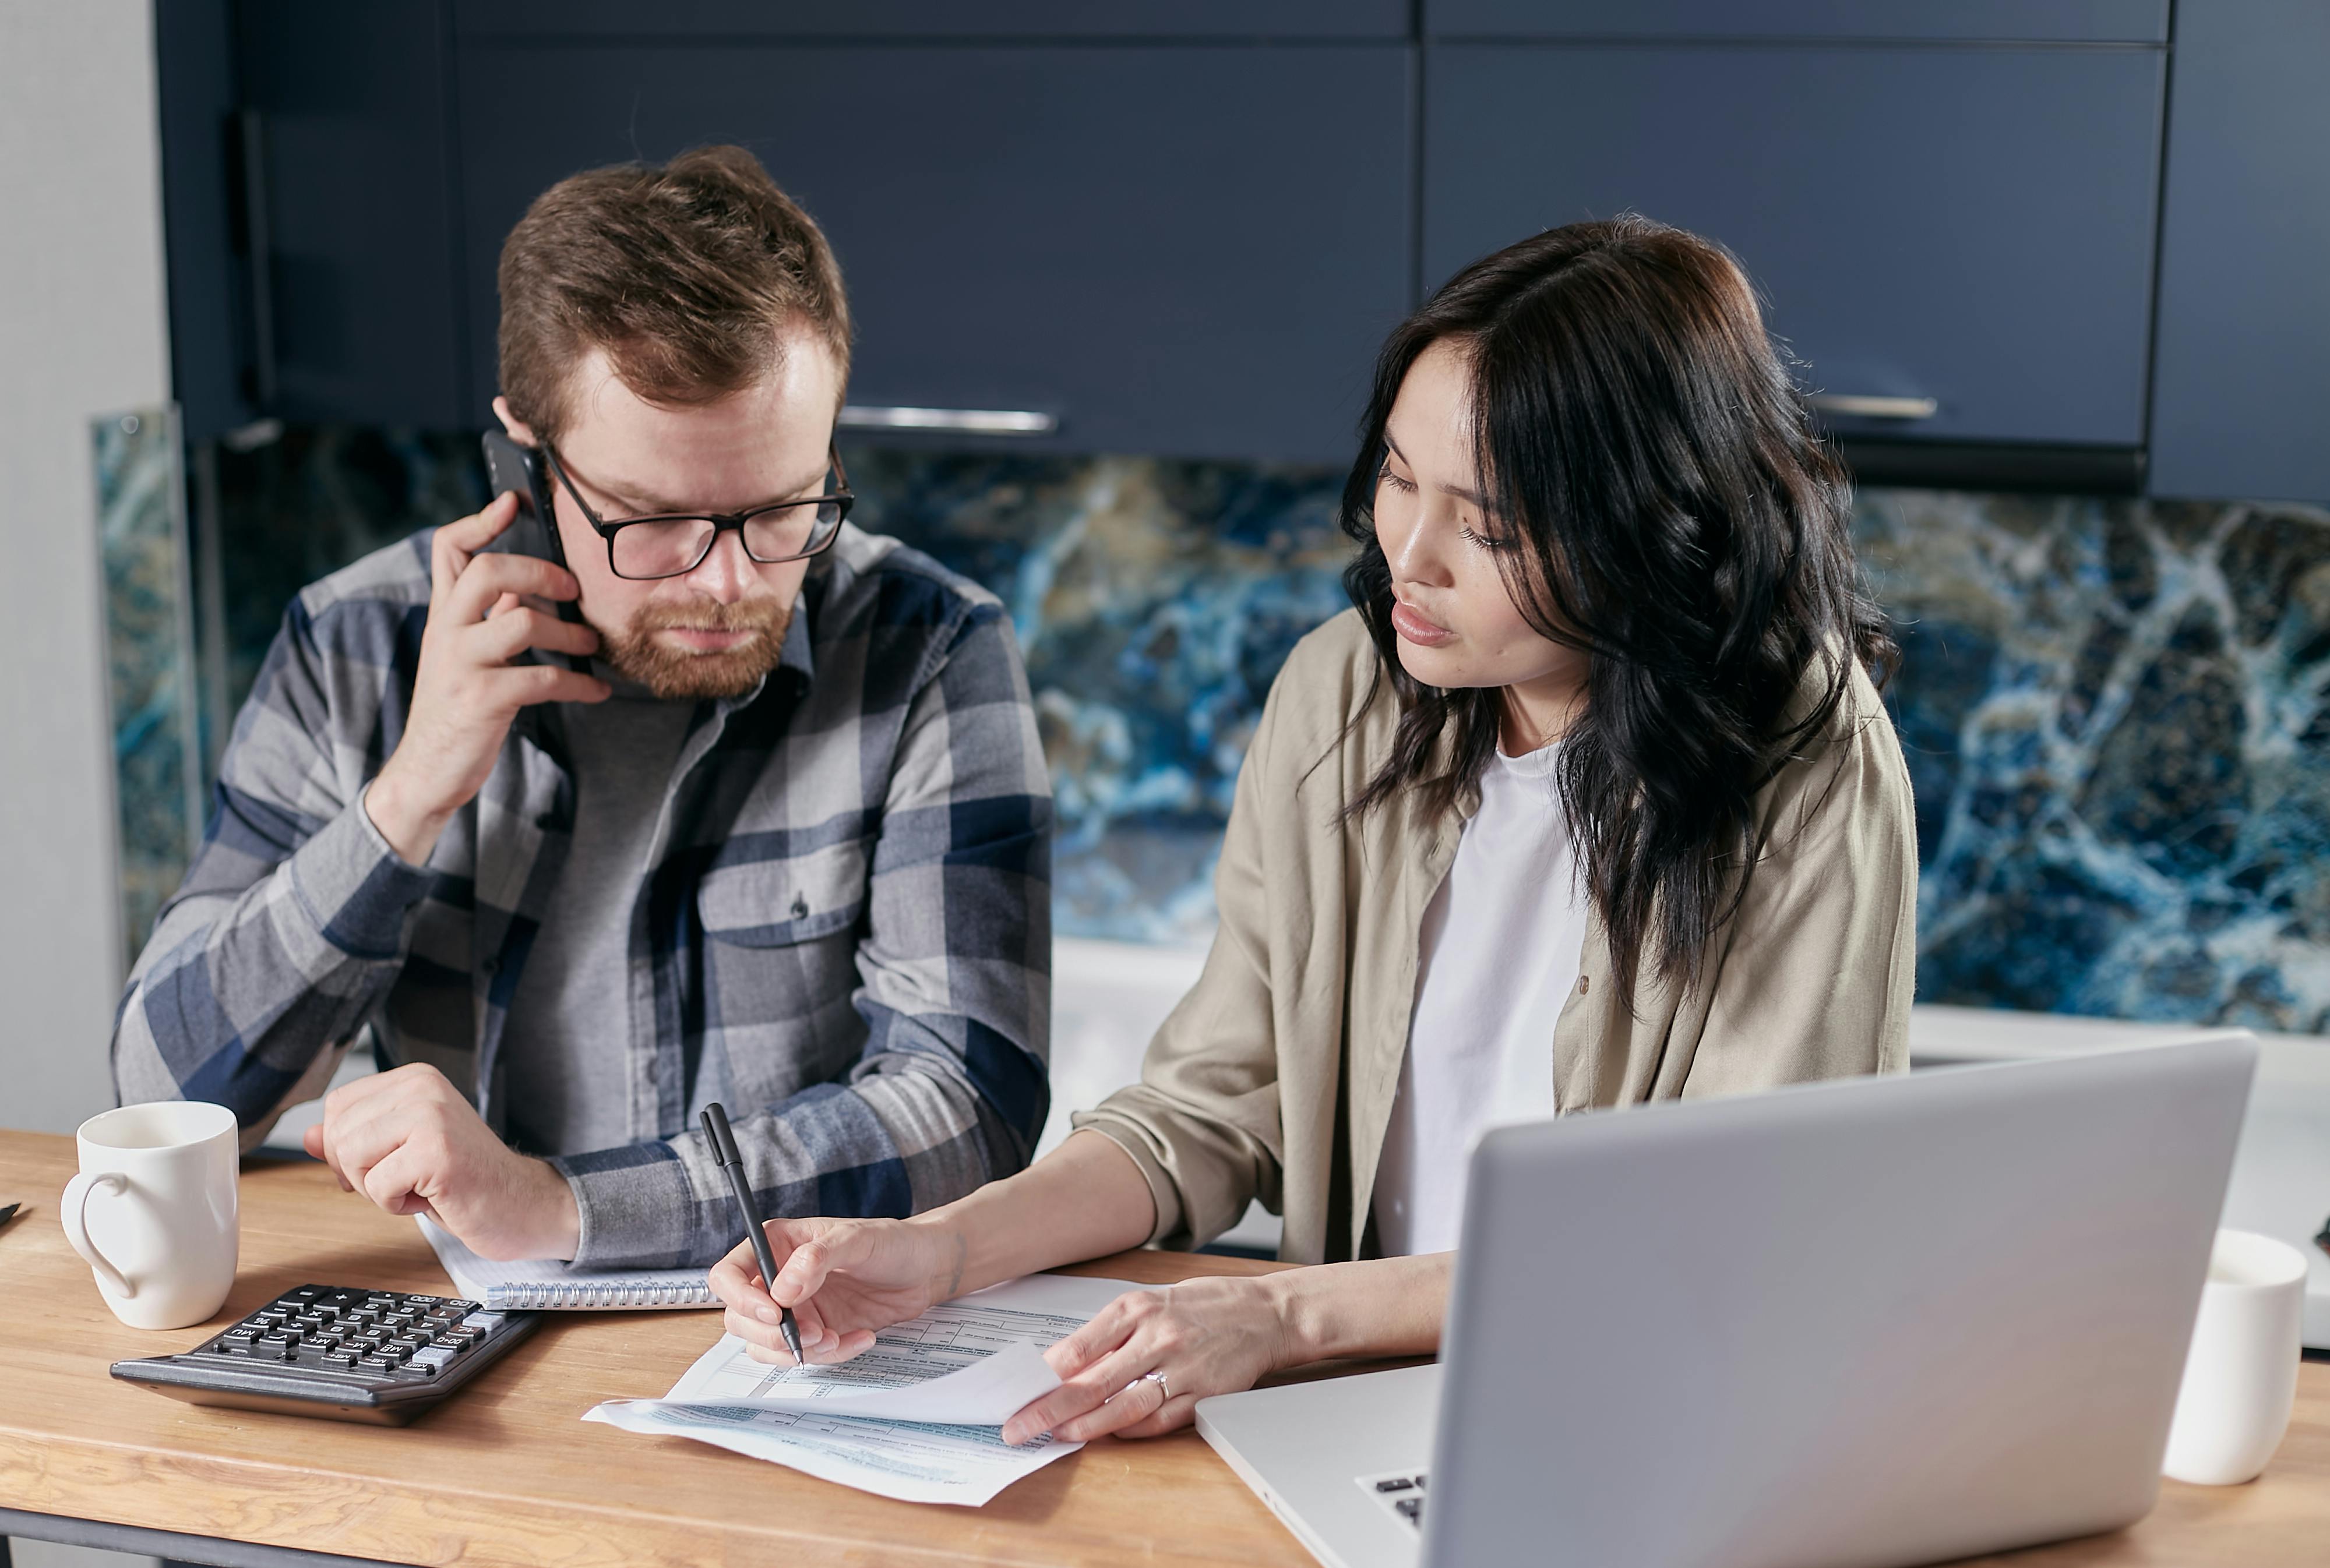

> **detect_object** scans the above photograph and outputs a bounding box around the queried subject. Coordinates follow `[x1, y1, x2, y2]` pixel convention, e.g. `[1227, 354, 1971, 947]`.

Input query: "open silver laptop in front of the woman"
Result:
[1197, 1032, 2258, 1568]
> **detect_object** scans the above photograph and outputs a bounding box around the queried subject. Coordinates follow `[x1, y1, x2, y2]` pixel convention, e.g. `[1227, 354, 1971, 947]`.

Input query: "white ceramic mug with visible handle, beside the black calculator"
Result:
[56, 1100, 242, 1328]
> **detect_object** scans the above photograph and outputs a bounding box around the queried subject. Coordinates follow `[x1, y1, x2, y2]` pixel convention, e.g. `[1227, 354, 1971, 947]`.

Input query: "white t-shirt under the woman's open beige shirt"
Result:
[1374, 746, 1587, 1258]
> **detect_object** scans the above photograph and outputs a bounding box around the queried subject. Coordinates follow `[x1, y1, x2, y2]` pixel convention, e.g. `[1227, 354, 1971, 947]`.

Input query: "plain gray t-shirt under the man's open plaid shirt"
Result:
[501, 671, 695, 1153]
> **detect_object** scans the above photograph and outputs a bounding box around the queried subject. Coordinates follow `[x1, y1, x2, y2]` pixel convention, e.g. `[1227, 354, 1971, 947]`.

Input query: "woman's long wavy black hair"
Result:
[1342, 214, 1894, 1007]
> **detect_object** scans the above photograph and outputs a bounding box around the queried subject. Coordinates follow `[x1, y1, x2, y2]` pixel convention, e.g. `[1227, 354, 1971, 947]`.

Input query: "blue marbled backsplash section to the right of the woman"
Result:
[1859, 492, 2330, 1032]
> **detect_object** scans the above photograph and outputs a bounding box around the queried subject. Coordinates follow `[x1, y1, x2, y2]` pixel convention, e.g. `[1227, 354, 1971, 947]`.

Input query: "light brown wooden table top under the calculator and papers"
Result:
[0, 1132, 2330, 1568]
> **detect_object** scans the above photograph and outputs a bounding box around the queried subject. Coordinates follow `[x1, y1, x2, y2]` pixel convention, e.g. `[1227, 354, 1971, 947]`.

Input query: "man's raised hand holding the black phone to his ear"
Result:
[364, 492, 611, 864]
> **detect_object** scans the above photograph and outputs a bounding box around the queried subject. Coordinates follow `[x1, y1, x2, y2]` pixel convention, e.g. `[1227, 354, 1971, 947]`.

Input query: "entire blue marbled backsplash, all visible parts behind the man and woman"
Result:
[177, 431, 2330, 1032]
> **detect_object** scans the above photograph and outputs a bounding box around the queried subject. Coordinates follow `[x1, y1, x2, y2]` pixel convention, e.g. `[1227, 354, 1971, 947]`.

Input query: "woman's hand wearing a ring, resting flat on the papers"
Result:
[1004, 1270, 1307, 1442]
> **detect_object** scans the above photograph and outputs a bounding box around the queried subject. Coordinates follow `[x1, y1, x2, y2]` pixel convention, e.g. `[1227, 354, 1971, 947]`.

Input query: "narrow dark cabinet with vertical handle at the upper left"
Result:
[156, 0, 464, 440]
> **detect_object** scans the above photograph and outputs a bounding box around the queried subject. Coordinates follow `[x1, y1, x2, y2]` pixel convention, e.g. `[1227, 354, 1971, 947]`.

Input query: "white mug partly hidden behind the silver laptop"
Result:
[2160, 1230, 2307, 1486]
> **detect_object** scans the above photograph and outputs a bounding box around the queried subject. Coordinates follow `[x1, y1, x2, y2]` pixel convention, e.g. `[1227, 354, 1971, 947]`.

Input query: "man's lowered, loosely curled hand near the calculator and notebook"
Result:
[305, 1062, 583, 1258]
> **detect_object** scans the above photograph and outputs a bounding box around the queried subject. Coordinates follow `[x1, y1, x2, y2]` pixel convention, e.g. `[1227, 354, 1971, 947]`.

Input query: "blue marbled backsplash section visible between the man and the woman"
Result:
[848, 452, 1349, 941]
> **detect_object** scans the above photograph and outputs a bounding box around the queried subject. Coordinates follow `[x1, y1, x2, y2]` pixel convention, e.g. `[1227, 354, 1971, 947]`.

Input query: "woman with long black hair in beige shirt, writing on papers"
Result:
[713, 217, 1915, 1442]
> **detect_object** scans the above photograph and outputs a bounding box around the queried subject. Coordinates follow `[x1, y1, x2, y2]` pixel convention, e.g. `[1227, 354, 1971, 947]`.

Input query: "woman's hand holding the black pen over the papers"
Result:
[711, 1219, 965, 1363]
